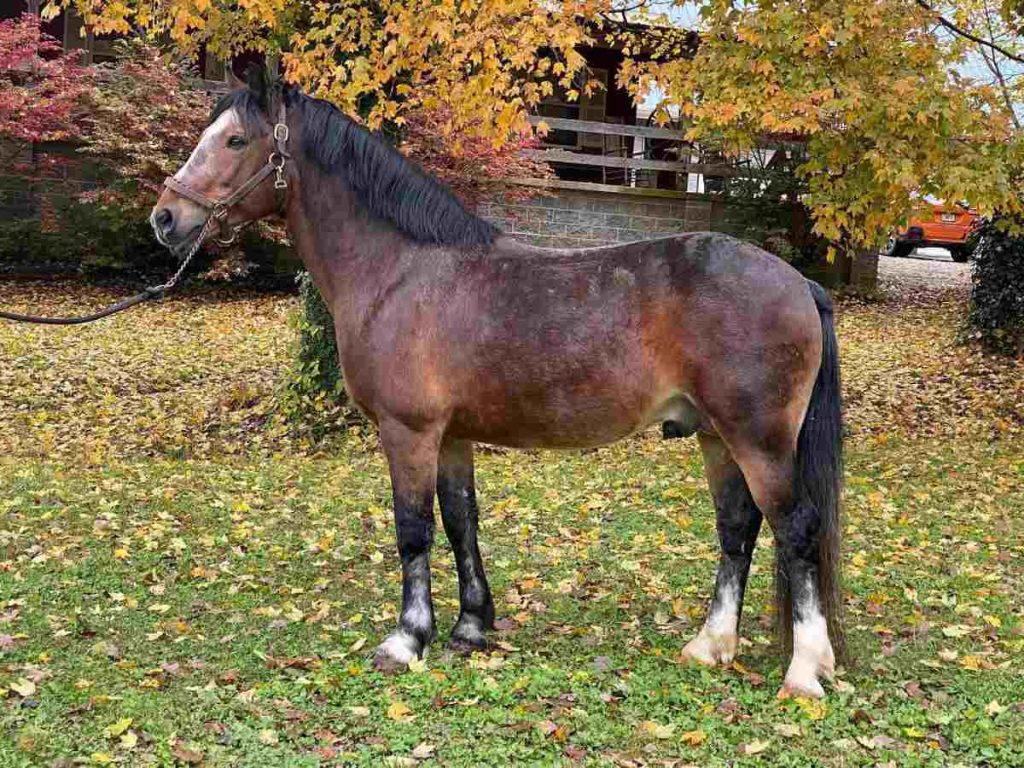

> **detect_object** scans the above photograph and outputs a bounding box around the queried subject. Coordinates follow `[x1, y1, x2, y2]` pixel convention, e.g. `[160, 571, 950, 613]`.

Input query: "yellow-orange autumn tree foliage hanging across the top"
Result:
[47, 0, 1021, 256]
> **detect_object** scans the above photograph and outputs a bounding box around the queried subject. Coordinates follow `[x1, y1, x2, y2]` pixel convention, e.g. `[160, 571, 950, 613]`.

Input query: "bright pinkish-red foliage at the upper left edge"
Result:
[0, 13, 92, 143]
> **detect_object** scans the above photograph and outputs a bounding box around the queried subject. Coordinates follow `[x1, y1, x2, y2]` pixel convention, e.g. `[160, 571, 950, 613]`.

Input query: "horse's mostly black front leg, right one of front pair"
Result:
[437, 440, 495, 649]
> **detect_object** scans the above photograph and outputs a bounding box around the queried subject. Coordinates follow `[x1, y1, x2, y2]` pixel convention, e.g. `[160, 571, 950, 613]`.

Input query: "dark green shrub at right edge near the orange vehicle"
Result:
[967, 218, 1024, 355]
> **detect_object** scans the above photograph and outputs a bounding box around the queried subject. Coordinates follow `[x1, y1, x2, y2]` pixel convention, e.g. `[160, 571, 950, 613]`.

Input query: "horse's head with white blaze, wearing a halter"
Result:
[150, 70, 290, 252]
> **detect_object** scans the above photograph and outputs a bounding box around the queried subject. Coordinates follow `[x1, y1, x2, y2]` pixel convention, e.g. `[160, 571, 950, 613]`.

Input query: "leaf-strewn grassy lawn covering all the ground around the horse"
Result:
[0, 274, 1024, 768]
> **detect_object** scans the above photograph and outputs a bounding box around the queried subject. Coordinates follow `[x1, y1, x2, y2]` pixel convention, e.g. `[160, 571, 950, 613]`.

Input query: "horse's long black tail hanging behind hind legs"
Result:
[775, 281, 846, 657]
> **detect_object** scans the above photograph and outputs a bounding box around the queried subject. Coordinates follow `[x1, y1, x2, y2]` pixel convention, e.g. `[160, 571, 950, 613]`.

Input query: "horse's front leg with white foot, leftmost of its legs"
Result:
[374, 422, 441, 670]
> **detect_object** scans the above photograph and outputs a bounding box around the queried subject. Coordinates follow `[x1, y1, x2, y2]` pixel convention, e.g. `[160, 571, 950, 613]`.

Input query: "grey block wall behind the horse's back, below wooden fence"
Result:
[479, 187, 713, 247]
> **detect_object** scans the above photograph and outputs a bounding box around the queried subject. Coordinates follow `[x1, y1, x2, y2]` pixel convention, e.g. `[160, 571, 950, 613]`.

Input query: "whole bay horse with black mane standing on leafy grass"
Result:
[151, 73, 843, 697]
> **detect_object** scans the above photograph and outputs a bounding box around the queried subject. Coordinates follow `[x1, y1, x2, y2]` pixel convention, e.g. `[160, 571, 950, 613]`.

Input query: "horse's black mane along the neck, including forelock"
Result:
[211, 76, 500, 246]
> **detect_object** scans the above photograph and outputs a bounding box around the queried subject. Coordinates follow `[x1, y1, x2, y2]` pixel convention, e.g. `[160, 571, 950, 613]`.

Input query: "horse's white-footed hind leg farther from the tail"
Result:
[683, 433, 762, 665]
